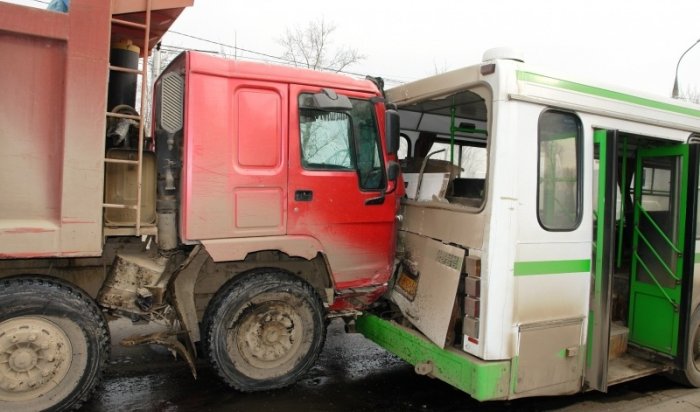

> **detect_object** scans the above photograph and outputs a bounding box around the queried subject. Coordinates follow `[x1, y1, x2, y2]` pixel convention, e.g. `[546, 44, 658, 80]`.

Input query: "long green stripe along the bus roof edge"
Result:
[517, 71, 700, 117]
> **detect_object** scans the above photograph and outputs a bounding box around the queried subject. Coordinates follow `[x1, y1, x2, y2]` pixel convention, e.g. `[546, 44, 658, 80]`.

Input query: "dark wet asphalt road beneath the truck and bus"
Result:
[82, 320, 697, 412]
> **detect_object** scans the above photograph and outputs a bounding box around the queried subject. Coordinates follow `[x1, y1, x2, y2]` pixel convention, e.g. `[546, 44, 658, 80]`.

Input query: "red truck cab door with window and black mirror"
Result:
[287, 85, 396, 289]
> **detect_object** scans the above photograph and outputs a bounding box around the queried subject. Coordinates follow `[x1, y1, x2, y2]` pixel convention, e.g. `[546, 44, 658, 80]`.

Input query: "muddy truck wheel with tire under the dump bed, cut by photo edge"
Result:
[0, 277, 109, 412]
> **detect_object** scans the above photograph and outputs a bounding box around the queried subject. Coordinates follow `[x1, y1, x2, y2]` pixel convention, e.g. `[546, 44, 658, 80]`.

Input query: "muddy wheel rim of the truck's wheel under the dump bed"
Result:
[0, 316, 73, 401]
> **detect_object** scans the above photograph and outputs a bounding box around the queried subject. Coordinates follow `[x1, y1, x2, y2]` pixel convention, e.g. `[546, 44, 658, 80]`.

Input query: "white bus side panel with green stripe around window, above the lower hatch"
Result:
[513, 103, 592, 324]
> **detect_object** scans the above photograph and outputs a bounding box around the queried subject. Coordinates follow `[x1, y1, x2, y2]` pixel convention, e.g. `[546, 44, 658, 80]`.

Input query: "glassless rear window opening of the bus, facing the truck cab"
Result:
[399, 86, 491, 211]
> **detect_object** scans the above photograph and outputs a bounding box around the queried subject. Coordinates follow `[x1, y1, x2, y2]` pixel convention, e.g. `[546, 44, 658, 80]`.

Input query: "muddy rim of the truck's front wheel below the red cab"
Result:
[227, 301, 309, 379]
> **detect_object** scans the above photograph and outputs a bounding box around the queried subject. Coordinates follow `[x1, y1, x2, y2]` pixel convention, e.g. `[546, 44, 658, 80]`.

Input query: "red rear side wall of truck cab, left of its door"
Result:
[182, 62, 288, 240]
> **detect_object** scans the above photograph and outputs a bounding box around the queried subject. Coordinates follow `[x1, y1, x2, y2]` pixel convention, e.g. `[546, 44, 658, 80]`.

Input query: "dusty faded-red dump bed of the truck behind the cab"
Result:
[0, 0, 192, 258]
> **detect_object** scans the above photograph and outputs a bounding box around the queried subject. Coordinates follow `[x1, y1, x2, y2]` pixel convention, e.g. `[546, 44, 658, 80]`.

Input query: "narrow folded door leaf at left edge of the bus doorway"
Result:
[586, 130, 618, 392]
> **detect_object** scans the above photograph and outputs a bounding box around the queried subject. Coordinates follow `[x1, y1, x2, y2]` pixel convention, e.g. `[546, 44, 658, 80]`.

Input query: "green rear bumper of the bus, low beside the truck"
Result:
[357, 315, 510, 401]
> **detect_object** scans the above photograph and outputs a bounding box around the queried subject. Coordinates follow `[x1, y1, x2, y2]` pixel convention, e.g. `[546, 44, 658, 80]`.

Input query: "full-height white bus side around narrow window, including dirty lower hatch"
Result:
[513, 103, 592, 397]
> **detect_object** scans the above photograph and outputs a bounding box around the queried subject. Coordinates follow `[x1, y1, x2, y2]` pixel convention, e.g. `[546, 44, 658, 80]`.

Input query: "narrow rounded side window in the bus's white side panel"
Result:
[537, 110, 582, 231]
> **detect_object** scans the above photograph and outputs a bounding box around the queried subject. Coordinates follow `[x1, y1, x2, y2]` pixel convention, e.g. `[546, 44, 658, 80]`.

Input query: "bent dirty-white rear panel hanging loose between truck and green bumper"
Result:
[389, 233, 464, 348]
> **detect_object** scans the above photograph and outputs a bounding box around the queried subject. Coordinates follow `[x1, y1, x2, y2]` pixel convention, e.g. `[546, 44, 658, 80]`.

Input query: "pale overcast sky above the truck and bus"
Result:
[5, 0, 700, 95]
